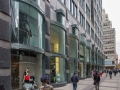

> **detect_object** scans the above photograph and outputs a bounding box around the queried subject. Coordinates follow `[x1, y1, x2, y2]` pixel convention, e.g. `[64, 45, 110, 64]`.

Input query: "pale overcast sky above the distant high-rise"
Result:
[102, 0, 120, 60]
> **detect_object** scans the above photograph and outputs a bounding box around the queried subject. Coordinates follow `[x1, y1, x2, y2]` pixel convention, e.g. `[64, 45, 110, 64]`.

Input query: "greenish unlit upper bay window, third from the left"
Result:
[69, 37, 78, 58]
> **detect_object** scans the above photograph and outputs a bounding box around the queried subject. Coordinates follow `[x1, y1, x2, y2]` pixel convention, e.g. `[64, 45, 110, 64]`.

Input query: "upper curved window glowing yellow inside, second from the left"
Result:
[50, 24, 65, 54]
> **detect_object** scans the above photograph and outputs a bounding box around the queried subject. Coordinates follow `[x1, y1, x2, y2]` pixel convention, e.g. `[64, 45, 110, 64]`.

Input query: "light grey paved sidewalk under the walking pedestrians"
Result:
[54, 74, 120, 90]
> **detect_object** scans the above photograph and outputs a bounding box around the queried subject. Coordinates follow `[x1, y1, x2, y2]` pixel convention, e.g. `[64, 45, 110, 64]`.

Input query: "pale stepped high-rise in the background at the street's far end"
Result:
[103, 10, 116, 69]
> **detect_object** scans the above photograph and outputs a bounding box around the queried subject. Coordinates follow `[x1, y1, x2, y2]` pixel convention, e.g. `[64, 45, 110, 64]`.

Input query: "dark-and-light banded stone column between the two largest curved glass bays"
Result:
[43, 0, 51, 82]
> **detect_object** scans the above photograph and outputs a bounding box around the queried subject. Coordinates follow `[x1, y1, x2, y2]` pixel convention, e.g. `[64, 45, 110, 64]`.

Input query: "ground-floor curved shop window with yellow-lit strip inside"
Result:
[50, 56, 66, 83]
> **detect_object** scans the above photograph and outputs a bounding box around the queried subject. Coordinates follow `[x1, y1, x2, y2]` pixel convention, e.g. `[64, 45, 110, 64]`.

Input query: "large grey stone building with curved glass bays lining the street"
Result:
[0, 0, 104, 90]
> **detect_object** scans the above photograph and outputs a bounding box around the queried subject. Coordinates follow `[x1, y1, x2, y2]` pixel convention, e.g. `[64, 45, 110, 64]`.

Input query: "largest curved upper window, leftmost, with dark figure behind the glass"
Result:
[11, 0, 43, 48]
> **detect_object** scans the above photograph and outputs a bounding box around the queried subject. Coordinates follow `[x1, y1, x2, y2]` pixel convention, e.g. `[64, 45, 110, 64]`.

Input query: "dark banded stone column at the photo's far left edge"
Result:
[0, 0, 11, 90]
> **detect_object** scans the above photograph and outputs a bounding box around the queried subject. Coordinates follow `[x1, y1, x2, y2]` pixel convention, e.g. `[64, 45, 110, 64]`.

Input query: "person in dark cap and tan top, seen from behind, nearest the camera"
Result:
[39, 76, 54, 90]
